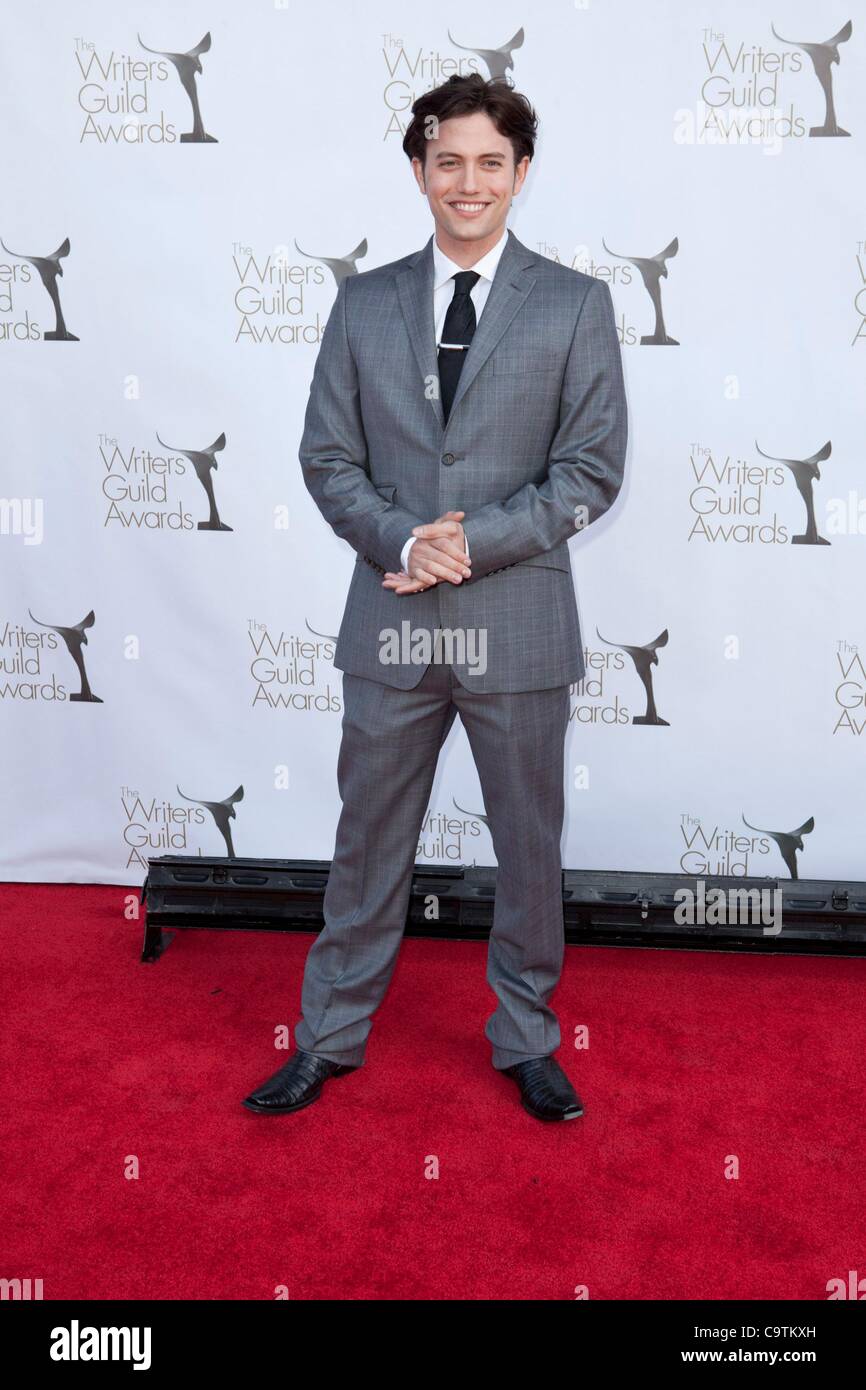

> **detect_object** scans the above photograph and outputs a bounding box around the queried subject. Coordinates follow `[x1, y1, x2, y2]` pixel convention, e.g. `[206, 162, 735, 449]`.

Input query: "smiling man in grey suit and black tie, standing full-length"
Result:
[243, 74, 627, 1120]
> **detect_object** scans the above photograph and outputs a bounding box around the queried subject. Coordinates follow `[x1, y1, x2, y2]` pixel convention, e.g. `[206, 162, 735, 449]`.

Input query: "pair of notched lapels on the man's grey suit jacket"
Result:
[396, 228, 535, 430]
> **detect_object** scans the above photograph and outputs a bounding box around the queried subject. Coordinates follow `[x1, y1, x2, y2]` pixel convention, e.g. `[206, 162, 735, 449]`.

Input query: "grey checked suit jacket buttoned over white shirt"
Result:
[299, 231, 628, 694]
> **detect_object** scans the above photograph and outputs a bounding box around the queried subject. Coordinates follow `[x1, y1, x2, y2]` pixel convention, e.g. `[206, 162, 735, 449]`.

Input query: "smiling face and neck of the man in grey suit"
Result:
[411, 111, 530, 268]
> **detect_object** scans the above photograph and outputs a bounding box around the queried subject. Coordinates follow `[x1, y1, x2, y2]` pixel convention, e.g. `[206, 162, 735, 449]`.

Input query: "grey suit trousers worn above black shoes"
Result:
[295, 660, 569, 1069]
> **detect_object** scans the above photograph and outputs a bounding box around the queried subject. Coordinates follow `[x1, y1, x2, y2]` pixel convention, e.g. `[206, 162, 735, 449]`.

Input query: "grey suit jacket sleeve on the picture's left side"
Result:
[299, 277, 423, 571]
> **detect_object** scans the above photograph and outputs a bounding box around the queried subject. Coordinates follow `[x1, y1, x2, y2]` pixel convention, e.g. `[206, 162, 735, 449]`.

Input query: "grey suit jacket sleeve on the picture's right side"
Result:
[463, 279, 628, 584]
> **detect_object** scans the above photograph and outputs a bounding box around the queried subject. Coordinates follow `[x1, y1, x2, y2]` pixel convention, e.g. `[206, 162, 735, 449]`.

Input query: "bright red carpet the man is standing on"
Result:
[0, 884, 866, 1300]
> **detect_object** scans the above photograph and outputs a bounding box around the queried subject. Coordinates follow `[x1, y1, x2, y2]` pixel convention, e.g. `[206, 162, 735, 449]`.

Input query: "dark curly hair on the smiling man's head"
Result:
[403, 72, 538, 167]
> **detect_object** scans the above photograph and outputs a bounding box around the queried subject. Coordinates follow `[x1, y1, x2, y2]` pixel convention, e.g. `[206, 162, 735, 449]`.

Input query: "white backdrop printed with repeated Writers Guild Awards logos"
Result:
[0, 0, 866, 884]
